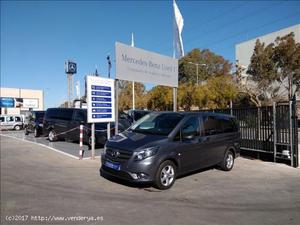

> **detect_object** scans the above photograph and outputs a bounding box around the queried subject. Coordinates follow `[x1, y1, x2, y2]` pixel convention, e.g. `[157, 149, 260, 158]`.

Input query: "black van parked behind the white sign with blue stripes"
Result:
[43, 108, 124, 146]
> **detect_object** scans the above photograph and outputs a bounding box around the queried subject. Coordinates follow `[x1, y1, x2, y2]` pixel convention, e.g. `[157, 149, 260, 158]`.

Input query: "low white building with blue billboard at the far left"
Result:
[0, 87, 44, 115]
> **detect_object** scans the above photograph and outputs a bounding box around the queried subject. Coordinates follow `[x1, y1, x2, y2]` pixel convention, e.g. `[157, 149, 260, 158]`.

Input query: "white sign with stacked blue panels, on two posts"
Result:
[87, 76, 115, 159]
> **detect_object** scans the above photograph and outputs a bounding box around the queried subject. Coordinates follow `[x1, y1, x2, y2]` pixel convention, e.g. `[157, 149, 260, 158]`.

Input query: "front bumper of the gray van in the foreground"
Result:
[100, 154, 157, 183]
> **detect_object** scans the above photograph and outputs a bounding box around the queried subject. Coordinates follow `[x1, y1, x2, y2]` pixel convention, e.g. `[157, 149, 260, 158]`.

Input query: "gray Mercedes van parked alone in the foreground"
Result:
[100, 112, 240, 189]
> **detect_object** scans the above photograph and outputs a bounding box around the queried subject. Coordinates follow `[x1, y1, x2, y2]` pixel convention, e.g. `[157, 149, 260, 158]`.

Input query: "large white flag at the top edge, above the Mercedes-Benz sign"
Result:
[173, 0, 184, 58]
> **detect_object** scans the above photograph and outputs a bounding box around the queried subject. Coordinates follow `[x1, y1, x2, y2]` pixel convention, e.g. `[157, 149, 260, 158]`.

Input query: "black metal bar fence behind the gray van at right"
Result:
[203, 101, 299, 167]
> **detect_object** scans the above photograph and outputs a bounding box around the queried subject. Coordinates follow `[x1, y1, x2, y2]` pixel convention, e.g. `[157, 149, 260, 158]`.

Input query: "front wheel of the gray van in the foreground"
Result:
[155, 160, 176, 190]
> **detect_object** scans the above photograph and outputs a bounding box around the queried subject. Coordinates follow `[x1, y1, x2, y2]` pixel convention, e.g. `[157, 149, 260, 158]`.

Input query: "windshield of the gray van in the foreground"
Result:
[129, 113, 183, 136]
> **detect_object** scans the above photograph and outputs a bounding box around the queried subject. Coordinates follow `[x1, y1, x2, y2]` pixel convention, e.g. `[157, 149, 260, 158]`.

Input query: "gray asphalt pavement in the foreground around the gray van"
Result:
[0, 136, 300, 225]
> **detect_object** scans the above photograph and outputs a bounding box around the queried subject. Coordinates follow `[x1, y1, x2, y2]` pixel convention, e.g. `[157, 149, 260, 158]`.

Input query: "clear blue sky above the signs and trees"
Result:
[1, 0, 300, 108]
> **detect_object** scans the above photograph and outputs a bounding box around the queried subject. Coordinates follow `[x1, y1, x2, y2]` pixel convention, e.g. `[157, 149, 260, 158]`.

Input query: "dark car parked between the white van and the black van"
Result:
[24, 111, 45, 137]
